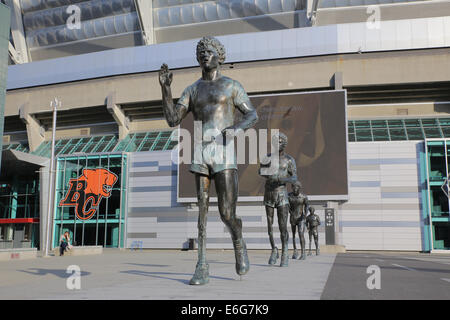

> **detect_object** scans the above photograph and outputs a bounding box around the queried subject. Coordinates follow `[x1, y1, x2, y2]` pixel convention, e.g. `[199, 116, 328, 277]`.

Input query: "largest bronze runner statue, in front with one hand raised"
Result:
[159, 37, 258, 285]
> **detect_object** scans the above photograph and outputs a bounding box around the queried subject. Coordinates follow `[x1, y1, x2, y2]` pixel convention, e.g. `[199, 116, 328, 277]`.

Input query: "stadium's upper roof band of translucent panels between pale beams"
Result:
[0, 0, 450, 64]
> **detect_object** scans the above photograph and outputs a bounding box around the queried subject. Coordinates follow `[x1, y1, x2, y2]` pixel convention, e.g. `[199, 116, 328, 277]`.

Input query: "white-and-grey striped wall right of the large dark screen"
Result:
[338, 141, 423, 251]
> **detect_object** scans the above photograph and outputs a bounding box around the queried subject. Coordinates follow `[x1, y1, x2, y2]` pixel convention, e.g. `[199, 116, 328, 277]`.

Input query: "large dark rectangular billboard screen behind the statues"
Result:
[178, 90, 348, 202]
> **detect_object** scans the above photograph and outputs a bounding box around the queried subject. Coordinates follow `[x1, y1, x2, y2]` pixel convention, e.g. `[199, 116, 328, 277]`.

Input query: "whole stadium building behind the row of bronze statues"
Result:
[0, 0, 450, 252]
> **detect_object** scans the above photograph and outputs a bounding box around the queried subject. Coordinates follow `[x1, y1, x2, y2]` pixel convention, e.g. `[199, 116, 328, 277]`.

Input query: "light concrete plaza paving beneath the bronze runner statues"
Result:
[0, 249, 336, 300]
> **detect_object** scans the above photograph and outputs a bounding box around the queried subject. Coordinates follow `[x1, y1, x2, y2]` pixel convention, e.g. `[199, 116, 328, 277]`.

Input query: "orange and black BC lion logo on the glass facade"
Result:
[59, 169, 118, 220]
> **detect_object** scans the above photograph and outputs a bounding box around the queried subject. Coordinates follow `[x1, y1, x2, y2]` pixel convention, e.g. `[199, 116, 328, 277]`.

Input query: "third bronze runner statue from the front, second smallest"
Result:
[289, 181, 309, 260]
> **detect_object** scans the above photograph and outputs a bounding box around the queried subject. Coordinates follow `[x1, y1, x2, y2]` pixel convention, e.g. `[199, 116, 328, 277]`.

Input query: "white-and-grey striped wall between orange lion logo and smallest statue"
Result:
[127, 151, 325, 249]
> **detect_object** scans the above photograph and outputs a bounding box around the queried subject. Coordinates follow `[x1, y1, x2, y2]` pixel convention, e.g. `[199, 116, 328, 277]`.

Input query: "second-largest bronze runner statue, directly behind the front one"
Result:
[259, 132, 297, 267]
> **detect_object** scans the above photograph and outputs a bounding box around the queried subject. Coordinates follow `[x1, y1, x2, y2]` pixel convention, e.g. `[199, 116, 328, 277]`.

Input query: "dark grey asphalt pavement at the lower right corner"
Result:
[321, 252, 450, 300]
